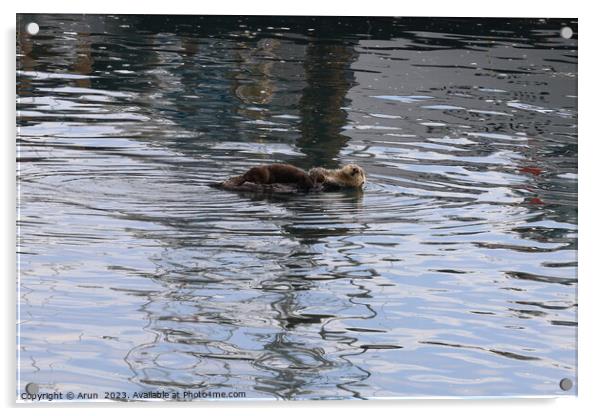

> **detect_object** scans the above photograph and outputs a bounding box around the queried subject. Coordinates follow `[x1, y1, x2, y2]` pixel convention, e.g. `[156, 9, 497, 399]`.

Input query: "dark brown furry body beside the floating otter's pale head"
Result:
[234, 163, 315, 191]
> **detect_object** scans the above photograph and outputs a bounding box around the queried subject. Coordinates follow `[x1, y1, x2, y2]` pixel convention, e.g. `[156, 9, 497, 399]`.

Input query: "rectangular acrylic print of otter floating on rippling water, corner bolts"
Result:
[17, 14, 578, 402]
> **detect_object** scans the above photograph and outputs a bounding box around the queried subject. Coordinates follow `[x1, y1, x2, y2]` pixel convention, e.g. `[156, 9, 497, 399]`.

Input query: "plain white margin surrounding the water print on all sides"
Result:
[0, 0, 602, 416]
